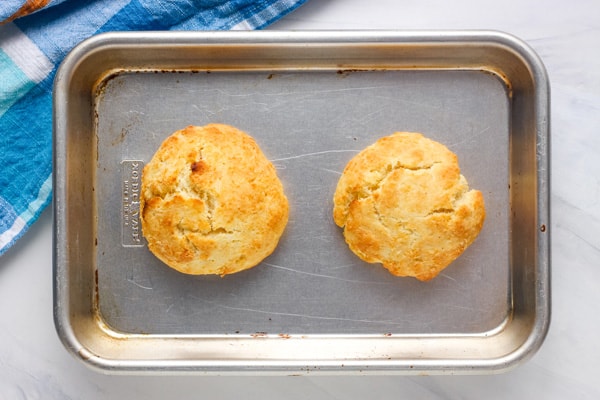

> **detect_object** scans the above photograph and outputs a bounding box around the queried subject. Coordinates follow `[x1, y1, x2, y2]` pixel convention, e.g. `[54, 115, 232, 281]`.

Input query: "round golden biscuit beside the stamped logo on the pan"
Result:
[140, 124, 288, 276]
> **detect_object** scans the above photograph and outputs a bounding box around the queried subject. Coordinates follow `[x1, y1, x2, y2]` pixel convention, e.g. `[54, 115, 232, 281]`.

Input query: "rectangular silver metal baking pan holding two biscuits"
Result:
[54, 31, 550, 374]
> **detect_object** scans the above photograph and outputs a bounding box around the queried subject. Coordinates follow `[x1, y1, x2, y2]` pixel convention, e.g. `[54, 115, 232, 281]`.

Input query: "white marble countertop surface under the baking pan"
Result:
[0, 0, 600, 400]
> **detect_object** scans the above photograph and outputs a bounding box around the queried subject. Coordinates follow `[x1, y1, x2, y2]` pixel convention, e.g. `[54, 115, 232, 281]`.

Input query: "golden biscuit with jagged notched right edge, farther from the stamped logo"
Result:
[333, 132, 485, 281]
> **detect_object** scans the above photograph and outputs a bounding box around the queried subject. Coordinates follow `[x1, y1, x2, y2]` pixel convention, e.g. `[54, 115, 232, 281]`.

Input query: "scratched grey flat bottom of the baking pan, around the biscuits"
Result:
[95, 68, 511, 335]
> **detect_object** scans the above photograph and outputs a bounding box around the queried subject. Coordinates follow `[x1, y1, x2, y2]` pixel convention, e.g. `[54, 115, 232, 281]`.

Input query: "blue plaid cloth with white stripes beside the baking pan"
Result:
[0, 0, 306, 255]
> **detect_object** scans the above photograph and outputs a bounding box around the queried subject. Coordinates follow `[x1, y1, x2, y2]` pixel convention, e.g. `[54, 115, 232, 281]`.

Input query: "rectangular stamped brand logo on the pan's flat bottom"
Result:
[121, 160, 145, 247]
